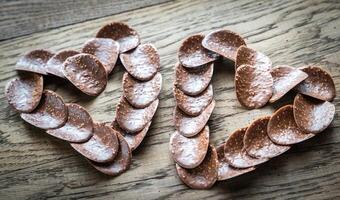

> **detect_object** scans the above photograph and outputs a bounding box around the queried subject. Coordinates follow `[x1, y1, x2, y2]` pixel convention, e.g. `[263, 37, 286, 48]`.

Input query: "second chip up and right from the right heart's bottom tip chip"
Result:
[224, 128, 268, 168]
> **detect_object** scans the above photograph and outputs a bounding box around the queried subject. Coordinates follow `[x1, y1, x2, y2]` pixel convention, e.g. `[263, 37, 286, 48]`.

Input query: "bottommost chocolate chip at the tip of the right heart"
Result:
[176, 145, 218, 189]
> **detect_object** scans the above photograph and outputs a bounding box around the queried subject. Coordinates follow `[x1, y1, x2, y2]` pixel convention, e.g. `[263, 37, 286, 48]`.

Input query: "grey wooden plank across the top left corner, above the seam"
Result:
[0, 0, 169, 40]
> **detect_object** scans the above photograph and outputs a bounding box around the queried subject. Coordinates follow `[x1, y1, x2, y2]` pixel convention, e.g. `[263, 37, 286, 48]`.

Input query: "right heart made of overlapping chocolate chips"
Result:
[170, 30, 335, 189]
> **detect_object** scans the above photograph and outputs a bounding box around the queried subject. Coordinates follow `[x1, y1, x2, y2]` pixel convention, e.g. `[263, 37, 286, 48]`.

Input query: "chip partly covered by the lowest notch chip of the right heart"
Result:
[235, 46, 272, 70]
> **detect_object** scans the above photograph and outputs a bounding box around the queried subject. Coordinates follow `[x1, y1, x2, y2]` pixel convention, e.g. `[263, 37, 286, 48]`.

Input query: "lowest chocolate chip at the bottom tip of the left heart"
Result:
[90, 133, 132, 176]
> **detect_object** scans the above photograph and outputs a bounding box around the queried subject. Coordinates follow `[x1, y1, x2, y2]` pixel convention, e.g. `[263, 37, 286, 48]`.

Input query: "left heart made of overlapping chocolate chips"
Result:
[6, 22, 162, 176]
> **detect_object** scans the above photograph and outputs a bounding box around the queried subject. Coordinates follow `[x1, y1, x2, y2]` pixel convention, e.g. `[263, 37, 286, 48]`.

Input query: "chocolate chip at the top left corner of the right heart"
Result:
[178, 34, 218, 68]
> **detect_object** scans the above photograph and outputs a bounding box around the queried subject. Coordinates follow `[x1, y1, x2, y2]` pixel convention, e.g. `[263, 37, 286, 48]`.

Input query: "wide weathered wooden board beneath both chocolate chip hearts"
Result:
[0, 0, 340, 199]
